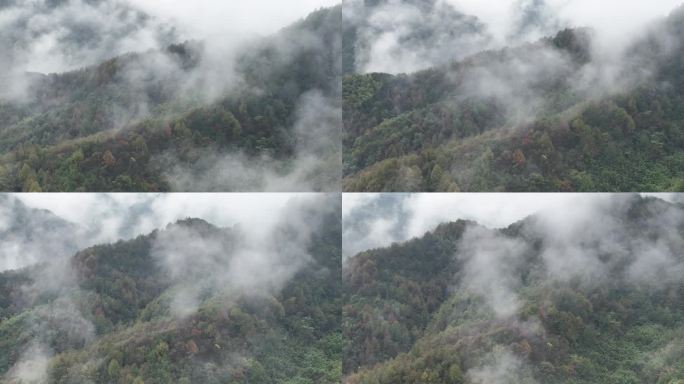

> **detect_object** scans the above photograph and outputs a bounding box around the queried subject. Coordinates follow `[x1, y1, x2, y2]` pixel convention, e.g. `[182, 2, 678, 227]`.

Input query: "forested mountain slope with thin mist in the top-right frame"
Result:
[343, 3, 684, 192]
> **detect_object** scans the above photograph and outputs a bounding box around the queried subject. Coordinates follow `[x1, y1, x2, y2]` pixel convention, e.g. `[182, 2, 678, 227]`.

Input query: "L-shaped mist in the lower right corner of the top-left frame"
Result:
[157, 90, 342, 192]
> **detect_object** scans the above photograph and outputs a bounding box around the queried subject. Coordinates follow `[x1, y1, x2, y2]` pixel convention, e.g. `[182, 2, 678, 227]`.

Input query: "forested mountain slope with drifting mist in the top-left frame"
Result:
[0, 6, 341, 191]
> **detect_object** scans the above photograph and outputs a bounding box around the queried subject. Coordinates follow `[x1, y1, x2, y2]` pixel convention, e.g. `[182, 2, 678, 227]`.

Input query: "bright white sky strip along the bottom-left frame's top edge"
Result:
[14, 193, 309, 241]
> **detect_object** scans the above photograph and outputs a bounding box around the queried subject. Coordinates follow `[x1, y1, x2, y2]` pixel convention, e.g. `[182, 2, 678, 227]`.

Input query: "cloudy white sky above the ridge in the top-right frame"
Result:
[347, 0, 682, 73]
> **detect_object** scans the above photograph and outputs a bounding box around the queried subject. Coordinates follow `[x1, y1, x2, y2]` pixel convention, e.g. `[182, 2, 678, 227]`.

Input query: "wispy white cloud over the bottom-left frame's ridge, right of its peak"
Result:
[152, 195, 339, 317]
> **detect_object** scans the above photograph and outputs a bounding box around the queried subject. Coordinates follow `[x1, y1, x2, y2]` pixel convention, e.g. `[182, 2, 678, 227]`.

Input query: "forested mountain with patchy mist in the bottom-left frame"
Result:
[0, 198, 342, 384]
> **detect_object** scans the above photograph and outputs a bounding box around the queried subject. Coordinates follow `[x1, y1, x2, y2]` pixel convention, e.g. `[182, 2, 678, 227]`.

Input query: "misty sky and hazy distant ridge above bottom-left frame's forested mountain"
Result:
[0, 193, 340, 272]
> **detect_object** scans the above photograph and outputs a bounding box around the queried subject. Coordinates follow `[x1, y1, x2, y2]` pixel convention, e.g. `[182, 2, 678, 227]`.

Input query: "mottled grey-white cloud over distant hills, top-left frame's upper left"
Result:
[0, 0, 177, 97]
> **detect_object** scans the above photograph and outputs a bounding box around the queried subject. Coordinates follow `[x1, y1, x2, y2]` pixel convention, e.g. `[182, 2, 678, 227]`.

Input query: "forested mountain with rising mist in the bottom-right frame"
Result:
[343, 195, 684, 384]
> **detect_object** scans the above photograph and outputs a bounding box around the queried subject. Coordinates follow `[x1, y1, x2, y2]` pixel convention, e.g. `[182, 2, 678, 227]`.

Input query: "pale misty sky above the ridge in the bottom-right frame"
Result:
[342, 193, 673, 257]
